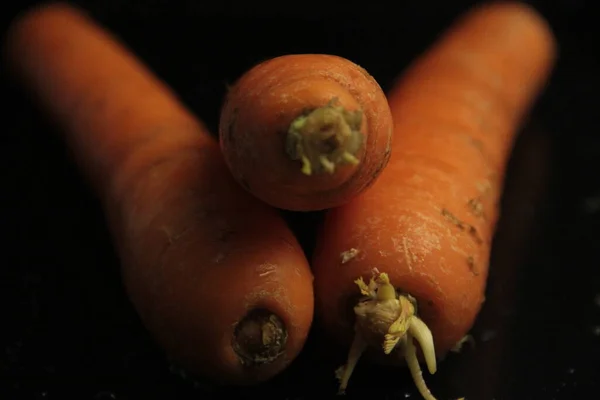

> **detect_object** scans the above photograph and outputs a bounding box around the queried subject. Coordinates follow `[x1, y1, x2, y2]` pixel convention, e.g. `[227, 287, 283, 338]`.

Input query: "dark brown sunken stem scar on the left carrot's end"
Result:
[232, 309, 287, 367]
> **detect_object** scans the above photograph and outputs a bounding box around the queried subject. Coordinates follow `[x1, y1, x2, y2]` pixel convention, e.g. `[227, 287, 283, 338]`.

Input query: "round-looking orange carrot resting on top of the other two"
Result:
[219, 54, 392, 211]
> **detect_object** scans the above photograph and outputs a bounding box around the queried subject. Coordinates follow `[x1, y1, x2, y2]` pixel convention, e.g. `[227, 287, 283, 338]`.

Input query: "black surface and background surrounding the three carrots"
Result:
[0, 0, 600, 400]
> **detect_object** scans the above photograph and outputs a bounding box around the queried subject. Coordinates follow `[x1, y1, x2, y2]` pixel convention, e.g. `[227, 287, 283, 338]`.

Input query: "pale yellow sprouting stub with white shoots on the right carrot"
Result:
[336, 270, 437, 400]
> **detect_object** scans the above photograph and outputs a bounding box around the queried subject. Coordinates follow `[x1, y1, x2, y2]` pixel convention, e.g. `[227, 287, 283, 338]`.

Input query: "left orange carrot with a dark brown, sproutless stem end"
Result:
[4, 3, 313, 384]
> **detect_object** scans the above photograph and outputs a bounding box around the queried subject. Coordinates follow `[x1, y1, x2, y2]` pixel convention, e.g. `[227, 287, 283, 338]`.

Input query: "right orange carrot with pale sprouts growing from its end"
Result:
[313, 2, 555, 399]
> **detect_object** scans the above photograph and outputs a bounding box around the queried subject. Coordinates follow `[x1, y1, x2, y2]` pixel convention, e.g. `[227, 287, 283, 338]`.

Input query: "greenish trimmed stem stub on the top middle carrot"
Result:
[286, 99, 364, 175]
